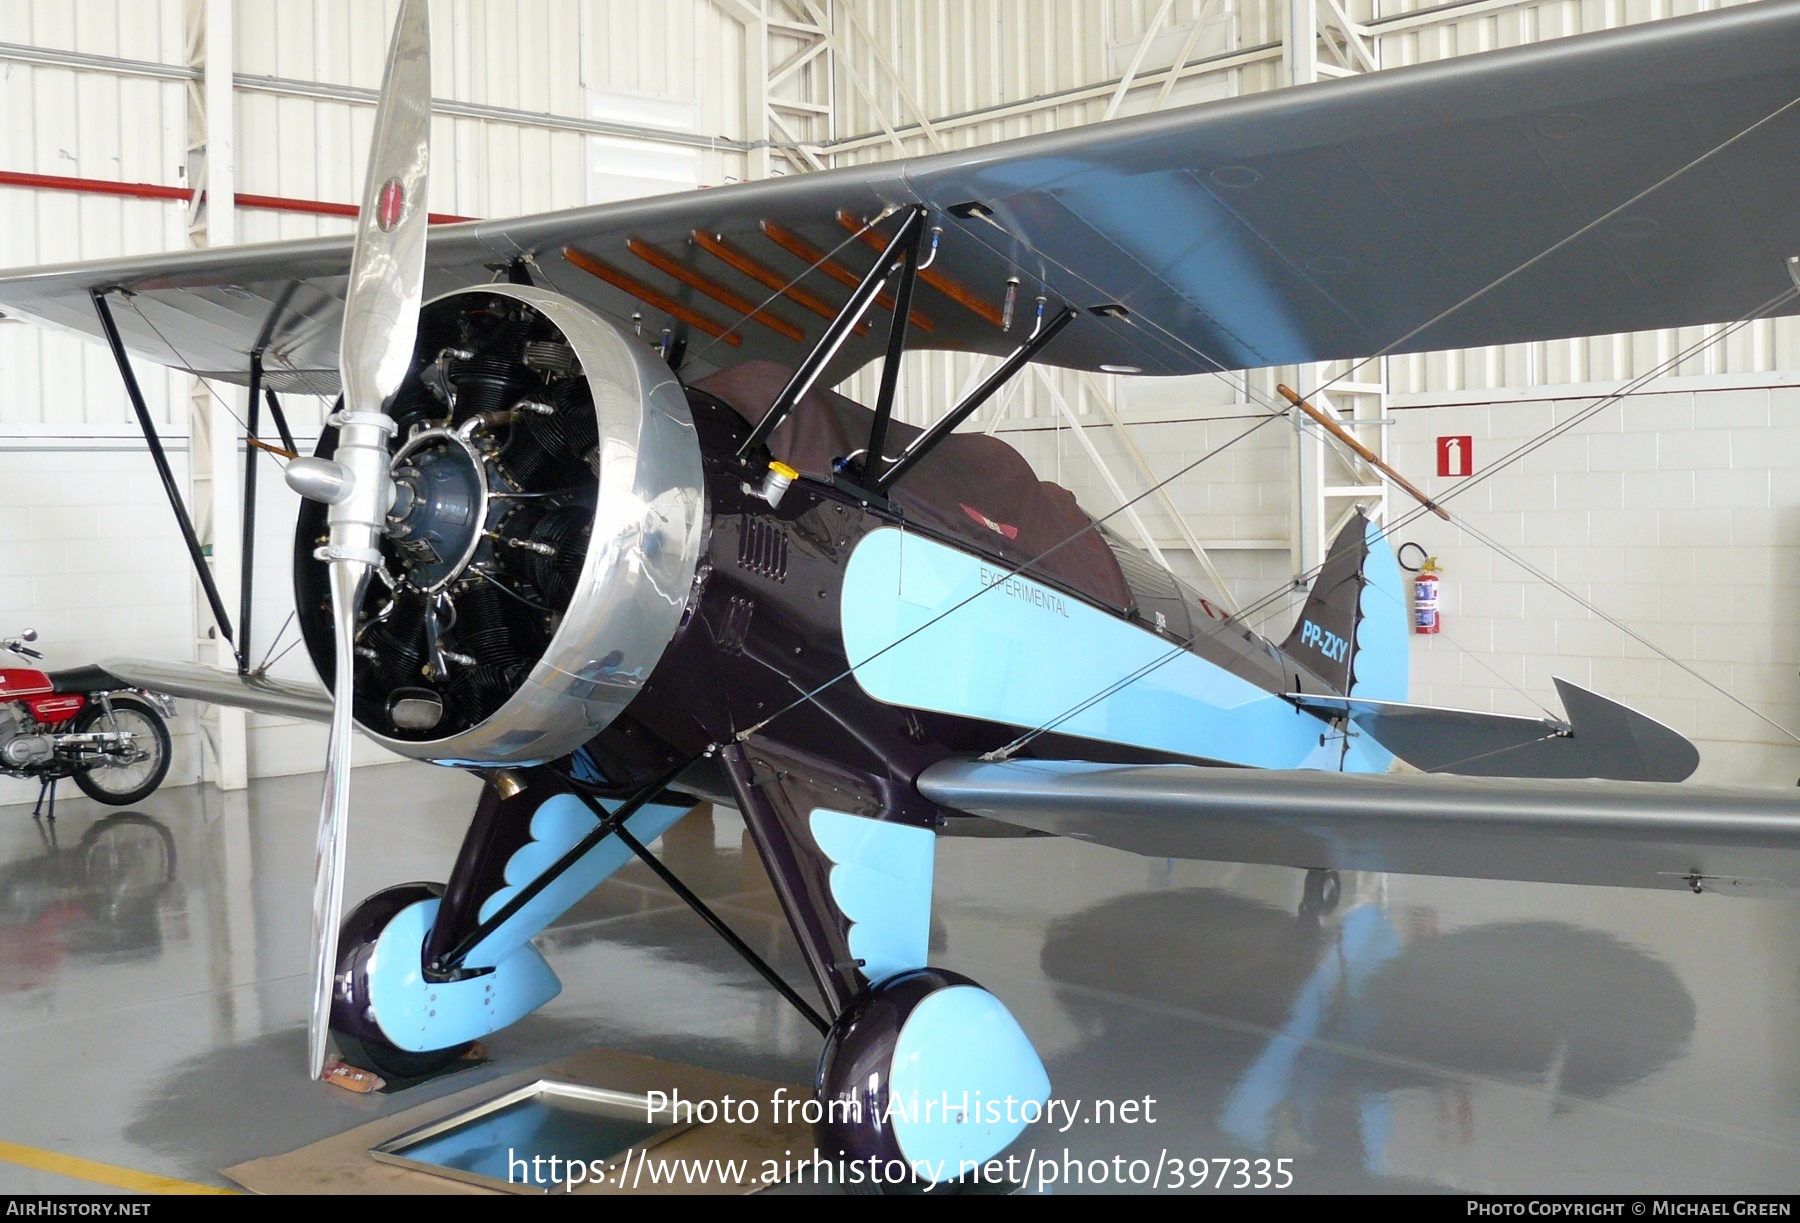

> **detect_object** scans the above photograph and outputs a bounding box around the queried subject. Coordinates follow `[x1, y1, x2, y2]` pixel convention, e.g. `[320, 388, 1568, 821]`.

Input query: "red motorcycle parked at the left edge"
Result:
[0, 629, 175, 820]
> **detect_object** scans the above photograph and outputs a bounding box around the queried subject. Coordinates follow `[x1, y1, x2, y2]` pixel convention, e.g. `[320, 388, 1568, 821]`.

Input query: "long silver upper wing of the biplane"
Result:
[0, 0, 1800, 391]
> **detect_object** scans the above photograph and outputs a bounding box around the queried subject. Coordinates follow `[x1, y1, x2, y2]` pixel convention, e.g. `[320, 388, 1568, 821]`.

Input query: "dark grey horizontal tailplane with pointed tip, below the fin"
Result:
[1289, 679, 1699, 782]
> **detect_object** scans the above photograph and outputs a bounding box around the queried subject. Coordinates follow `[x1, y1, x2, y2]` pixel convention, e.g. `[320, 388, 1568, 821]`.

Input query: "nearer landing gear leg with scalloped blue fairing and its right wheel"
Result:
[720, 744, 1049, 1194]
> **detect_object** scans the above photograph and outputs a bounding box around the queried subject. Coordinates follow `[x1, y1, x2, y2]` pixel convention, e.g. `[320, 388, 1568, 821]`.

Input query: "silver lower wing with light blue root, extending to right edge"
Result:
[918, 760, 1800, 893]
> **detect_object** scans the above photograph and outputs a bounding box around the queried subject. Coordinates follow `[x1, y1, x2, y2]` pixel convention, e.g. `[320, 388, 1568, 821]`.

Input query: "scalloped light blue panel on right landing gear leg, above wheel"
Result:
[810, 809, 938, 985]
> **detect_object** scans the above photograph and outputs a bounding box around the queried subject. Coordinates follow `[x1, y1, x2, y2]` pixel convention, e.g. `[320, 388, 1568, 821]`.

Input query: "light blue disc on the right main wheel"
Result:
[887, 985, 1049, 1180]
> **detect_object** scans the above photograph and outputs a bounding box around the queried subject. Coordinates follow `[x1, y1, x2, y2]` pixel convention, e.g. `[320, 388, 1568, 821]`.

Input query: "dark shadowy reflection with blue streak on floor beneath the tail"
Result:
[1040, 877, 1697, 1178]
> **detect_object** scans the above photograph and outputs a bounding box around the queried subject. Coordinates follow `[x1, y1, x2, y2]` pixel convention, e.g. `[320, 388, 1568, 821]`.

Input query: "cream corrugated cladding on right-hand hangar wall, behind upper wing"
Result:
[832, 0, 1800, 437]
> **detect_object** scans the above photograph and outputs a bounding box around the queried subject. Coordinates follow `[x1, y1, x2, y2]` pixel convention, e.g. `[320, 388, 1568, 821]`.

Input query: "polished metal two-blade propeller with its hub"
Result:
[286, 0, 432, 1079]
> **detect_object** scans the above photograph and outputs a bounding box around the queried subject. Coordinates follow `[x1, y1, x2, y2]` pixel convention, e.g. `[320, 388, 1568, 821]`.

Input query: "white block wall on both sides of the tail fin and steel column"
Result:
[943, 365, 1800, 785]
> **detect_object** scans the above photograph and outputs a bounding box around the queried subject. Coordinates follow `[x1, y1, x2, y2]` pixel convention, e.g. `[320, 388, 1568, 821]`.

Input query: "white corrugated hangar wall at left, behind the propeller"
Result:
[0, 0, 745, 802]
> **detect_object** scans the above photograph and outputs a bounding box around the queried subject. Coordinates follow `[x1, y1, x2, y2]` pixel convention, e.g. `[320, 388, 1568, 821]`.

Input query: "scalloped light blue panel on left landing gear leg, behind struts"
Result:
[464, 794, 689, 969]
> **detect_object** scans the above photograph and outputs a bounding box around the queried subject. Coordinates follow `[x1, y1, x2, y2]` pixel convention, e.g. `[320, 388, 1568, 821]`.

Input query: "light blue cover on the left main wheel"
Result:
[369, 901, 562, 1054]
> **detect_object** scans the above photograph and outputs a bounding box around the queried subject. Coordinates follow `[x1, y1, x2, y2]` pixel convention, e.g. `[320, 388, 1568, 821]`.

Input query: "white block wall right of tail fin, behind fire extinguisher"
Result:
[1393, 376, 1800, 785]
